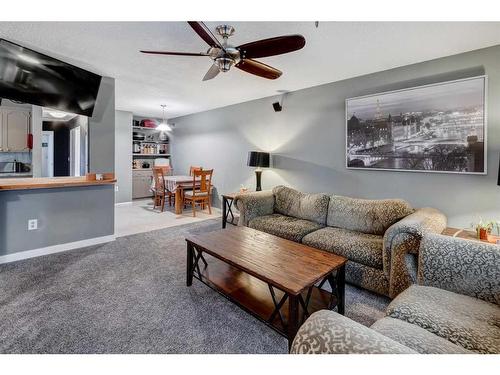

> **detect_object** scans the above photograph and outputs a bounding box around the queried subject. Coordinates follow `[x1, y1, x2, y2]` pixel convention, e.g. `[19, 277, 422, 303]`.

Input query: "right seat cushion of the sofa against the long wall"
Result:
[302, 227, 382, 269]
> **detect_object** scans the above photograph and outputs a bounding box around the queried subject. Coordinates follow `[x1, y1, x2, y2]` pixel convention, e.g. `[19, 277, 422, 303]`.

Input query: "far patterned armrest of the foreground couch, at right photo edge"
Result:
[418, 234, 500, 305]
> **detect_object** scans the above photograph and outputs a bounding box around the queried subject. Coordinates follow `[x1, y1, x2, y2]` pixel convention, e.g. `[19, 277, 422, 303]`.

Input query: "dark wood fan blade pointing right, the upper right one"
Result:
[238, 35, 306, 59]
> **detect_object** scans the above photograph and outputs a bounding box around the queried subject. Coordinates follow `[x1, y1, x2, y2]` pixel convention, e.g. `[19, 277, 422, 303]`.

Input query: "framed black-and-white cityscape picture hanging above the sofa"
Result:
[346, 76, 487, 174]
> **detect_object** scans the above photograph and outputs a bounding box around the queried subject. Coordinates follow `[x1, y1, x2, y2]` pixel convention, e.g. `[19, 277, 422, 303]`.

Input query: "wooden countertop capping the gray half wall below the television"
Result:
[0, 173, 116, 191]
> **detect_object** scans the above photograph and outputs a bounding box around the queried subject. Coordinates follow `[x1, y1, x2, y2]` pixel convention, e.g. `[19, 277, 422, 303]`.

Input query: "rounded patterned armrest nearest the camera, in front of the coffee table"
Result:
[290, 310, 415, 354]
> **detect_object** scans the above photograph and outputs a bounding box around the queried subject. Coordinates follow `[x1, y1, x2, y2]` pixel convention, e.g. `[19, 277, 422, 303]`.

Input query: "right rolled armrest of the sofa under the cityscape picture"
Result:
[383, 207, 447, 298]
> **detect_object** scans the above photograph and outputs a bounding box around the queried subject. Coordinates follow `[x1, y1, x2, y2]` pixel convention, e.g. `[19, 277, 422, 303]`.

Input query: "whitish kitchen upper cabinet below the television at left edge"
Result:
[0, 108, 31, 152]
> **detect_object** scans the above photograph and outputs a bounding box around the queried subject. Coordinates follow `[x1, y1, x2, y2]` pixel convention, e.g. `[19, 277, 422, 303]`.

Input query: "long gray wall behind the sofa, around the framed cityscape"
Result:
[172, 46, 500, 227]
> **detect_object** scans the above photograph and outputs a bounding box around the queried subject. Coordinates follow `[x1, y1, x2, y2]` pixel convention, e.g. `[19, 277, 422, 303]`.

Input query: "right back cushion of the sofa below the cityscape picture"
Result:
[327, 195, 414, 235]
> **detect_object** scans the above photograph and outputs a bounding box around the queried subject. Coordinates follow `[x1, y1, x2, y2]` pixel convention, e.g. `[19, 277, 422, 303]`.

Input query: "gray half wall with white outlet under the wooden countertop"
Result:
[0, 185, 114, 256]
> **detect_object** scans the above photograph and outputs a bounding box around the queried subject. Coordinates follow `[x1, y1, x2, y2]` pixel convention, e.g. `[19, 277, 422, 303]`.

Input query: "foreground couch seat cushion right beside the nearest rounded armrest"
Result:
[370, 317, 473, 354]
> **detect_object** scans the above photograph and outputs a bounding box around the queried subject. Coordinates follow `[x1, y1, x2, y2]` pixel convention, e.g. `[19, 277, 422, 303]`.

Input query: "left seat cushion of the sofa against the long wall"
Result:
[248, 214, 323, 242]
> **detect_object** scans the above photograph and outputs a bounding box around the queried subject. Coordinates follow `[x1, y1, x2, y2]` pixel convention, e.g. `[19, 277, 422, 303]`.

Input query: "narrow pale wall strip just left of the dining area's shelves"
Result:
[115, 111, 132, 203]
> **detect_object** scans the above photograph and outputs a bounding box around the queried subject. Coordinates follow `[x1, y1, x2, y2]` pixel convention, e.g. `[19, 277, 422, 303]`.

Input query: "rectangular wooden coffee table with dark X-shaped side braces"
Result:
[186, 227, 347, 345]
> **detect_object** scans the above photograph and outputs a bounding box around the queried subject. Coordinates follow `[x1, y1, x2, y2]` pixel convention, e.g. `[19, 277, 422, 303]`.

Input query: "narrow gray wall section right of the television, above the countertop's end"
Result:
[89, 77, 115, 173]
